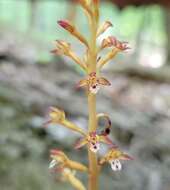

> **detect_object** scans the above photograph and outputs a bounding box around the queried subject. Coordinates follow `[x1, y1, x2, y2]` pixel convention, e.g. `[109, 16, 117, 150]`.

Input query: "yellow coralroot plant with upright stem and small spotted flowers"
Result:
[45, 0, 132, 190]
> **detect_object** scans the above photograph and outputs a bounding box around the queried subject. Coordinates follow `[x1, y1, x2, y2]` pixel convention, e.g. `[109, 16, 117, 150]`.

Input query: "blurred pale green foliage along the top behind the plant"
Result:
[0, 0, 166, 45]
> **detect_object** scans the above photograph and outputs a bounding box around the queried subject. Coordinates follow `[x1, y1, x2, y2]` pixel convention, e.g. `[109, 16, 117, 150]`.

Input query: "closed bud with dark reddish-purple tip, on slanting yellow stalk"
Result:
[58, 20, 89, 47]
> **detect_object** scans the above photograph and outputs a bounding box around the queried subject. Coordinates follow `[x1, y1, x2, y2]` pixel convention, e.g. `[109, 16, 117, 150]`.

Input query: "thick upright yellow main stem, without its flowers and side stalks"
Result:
[88, 12, 98, 190]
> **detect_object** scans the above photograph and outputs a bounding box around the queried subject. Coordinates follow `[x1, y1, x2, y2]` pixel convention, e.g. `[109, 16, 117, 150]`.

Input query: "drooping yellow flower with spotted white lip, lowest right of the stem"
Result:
[99, 148, 133, 171]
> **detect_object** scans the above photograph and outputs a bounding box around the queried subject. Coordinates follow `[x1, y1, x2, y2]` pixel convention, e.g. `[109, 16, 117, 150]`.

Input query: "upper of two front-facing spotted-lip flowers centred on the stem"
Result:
[77, 72, 111, 94]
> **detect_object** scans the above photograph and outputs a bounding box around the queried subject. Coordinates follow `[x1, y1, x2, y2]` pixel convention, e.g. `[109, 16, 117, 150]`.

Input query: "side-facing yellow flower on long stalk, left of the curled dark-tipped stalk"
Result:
[44, 107, 86, 136]
